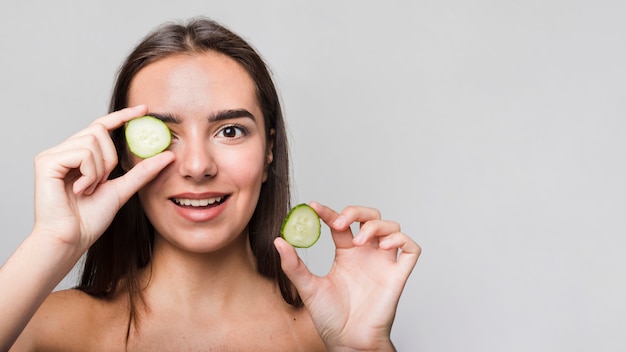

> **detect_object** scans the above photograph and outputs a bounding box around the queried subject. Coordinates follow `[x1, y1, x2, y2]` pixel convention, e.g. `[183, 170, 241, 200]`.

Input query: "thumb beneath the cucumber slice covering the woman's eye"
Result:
[109, 151, 175, 203]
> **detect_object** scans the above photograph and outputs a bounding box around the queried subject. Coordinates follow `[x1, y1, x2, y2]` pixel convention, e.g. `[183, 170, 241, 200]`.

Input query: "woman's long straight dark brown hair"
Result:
[77, 18, 302, 328]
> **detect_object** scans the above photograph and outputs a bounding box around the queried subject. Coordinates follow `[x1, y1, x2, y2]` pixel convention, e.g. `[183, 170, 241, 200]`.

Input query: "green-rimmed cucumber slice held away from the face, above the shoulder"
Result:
[280, 204, 322, 248]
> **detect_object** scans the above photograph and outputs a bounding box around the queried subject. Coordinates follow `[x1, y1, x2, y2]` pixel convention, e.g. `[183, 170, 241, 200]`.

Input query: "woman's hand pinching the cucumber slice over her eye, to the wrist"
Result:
[33, 105, 174, 253]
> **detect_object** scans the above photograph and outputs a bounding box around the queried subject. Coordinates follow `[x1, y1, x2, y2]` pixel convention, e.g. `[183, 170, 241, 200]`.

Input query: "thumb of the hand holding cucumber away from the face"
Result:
[274, 237, 317, 299]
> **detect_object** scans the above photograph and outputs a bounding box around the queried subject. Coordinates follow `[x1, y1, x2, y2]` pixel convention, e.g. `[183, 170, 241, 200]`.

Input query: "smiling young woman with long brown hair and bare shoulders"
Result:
[0, 18, 420, 351]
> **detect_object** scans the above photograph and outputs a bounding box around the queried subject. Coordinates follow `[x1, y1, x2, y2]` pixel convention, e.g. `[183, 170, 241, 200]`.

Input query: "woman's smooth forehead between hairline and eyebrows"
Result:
[128, 51, 262, 120]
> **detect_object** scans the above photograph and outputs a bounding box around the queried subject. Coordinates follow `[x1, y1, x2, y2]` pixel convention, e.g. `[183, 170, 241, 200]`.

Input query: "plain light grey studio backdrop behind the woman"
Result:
[0, 0, 626, 352]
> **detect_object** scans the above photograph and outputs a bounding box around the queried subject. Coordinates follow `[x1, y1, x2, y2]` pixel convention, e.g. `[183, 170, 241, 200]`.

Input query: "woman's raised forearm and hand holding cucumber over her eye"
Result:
[0, 106, 174, 350]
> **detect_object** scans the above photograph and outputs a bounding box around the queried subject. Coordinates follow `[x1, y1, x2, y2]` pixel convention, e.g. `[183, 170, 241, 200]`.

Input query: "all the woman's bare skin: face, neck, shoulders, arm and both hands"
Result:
[0, 48, 421, 351]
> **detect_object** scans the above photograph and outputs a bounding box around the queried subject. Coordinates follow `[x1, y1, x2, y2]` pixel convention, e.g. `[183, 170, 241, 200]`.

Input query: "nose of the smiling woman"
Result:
[176, 138, 217, 181]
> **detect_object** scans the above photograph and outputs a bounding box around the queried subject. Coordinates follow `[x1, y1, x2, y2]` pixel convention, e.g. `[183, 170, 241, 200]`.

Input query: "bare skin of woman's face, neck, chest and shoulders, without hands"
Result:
[14, 54, 325, 351]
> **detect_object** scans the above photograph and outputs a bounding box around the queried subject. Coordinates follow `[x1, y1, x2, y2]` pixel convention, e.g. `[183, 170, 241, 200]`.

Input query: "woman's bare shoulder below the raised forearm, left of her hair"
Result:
[13, 289, 125, 351]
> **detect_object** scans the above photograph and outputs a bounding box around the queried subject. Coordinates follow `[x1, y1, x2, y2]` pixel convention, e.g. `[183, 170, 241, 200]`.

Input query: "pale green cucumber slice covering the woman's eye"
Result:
[125, 116, 172, 159]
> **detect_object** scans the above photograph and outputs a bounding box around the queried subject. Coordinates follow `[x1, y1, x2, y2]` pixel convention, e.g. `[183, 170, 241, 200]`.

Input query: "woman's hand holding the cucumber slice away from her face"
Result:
[274, 202, 421, 350]
